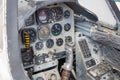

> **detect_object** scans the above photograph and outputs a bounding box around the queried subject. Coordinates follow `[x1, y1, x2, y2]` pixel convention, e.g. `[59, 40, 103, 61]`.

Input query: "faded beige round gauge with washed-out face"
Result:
[38, 26, 50, 39]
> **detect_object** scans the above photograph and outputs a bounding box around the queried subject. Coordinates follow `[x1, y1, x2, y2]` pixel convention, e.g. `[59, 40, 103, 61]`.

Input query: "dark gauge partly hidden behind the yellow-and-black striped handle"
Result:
[21, 28, 37, 44]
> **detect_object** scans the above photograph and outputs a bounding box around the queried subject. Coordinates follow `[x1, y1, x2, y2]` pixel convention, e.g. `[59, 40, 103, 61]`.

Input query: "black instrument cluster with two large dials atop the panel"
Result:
[36, 7, 63, 24]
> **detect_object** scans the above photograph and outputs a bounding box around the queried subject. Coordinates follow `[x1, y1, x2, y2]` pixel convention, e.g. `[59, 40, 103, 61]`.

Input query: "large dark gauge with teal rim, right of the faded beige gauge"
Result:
[51, 23, 62, 36]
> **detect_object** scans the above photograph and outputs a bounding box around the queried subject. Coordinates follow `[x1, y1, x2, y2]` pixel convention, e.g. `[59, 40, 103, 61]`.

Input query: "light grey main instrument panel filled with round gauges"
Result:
[19, 4, 75, 72]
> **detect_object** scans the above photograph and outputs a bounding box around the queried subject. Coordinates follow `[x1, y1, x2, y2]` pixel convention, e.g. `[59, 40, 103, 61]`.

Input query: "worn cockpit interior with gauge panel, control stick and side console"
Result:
[0, 0, 120, 80]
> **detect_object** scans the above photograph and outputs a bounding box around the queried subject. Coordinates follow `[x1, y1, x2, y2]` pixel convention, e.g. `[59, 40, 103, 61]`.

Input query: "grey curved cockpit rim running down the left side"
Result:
[6, 0, 29, 80]
